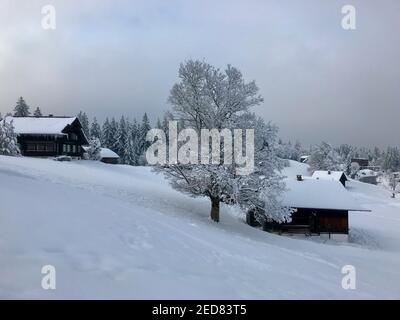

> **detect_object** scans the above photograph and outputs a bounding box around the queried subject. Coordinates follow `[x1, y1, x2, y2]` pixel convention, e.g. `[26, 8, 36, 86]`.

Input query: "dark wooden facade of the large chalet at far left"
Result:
[17, 119, 89, 157]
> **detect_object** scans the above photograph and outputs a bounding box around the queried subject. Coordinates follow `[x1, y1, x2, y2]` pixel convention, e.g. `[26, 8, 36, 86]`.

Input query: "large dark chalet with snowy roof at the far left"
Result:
[4, 116, 89, 157]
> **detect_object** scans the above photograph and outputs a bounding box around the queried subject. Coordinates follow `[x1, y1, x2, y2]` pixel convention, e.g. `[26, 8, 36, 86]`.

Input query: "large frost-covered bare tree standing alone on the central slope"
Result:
[156, 60, 289, 225]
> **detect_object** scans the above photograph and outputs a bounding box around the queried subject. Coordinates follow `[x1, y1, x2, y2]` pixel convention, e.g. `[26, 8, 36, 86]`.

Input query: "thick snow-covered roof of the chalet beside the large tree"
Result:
[282, 178, 369, 211]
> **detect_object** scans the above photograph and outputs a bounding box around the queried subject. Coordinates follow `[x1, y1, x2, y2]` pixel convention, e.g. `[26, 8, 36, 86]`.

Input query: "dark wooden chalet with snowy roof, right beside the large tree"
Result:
[247, 176, 369, 241]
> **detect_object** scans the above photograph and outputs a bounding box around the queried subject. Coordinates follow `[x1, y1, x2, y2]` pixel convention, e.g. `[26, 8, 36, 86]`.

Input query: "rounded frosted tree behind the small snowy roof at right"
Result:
[308, 142, 344, 171]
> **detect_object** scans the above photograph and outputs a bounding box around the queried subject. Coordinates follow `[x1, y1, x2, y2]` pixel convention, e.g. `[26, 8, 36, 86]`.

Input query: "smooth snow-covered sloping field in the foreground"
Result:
[0, 156, 400, 299]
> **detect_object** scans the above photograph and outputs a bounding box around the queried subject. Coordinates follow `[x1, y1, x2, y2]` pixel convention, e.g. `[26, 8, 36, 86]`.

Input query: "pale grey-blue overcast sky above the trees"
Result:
[0, 0, 400, 146]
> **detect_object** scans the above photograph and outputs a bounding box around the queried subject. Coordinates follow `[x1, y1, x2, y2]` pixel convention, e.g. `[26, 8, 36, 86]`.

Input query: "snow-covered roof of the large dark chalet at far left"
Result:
[5, 116, 76, 135]
